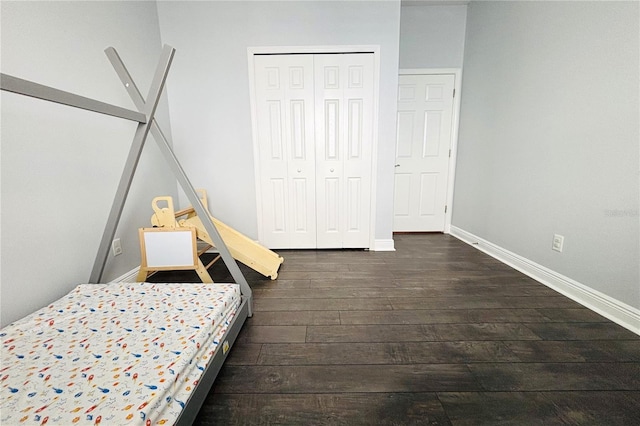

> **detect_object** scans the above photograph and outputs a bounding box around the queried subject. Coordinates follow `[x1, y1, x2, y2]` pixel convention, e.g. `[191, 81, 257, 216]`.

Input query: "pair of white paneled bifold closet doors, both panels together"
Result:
[254, 54, 374, 248]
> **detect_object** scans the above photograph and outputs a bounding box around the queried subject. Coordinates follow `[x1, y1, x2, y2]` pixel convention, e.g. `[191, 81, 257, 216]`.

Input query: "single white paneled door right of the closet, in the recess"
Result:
[393, 74, 455, 232]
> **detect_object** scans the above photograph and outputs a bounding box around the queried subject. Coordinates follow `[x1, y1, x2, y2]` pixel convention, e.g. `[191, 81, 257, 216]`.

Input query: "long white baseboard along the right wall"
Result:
[451, 226, 640, 335]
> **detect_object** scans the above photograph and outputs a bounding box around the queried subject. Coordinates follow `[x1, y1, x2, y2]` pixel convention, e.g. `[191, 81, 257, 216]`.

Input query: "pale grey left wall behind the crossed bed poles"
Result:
[0, 1, 176, 325]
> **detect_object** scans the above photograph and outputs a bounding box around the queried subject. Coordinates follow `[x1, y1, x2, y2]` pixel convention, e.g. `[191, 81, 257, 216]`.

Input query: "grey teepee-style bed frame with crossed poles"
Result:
[0, 45, 253, 425]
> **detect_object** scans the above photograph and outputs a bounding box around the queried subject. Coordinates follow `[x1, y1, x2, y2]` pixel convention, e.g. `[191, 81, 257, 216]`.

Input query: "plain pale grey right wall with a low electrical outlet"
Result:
[453, 1, 640, 309]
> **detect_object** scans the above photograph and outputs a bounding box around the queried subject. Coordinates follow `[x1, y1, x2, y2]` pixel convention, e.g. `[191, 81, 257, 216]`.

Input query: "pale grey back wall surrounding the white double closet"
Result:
[158, 1, 400, 240]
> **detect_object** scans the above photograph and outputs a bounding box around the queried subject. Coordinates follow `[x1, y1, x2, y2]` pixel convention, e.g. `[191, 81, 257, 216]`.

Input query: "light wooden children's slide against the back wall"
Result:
[151, 190, 284, 280]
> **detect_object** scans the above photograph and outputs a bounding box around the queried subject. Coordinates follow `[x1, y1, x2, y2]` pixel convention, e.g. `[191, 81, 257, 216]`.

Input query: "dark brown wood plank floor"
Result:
[151, 234, 640, 426]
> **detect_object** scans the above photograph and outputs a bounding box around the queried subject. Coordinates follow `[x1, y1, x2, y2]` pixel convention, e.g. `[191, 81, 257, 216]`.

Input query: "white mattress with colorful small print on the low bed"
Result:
[0, 283, 241, 425]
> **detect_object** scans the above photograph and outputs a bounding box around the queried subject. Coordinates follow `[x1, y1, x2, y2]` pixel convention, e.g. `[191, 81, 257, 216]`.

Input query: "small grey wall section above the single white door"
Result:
[400, 2, 467, 69]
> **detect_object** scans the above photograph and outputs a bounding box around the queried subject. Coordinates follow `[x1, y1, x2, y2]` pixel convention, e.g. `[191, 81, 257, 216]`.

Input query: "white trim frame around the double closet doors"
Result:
[247, 45, 380, 250]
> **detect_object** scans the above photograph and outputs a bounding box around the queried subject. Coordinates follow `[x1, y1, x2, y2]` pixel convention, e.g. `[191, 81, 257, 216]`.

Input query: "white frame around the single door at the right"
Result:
[394, 68, 462, 234]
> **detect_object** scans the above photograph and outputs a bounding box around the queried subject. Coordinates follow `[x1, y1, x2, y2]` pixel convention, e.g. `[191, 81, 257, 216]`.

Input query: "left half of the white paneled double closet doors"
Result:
[254, 55, 316, 248]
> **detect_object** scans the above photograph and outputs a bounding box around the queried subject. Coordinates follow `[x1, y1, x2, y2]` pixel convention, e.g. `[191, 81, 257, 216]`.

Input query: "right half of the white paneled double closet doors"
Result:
[314, 54, 374, 248]
